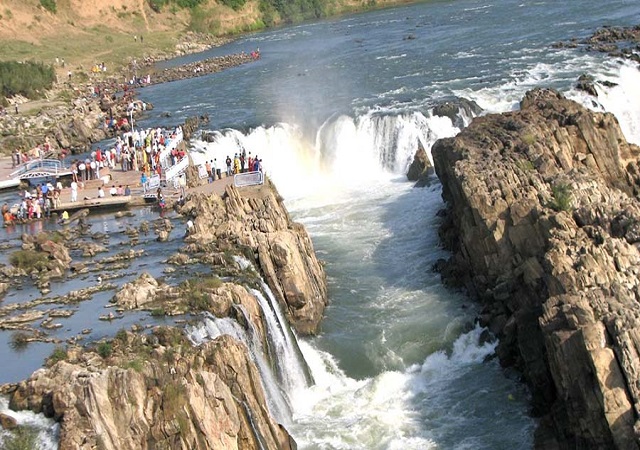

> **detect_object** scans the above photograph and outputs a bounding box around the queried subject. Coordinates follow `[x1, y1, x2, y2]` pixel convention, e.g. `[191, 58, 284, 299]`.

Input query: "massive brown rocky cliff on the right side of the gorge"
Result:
[432, 89, 640, 449]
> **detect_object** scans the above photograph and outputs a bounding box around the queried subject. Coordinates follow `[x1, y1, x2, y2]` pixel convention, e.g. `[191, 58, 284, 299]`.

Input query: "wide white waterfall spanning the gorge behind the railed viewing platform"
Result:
[191, 107, 470, 199]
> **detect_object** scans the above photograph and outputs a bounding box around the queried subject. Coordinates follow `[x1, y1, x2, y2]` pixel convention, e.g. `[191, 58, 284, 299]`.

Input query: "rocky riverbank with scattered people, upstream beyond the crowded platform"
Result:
[0, 34, 258, 155]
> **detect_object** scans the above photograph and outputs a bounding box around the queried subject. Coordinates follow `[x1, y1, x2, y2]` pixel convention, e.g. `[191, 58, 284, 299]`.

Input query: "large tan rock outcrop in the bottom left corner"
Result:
[3, 328, 295, 450]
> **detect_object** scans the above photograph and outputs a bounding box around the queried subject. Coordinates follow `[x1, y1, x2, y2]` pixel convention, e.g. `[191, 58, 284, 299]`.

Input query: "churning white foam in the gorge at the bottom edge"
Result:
[291, 328, 512, 449]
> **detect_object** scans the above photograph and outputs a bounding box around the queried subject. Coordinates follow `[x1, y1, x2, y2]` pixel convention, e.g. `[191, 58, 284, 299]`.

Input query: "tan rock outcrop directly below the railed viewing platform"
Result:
[180, 181, 327, 334]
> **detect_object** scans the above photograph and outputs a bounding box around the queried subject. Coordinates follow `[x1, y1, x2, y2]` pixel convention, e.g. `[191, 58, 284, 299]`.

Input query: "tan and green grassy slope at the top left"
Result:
[0, 0, 407, 74]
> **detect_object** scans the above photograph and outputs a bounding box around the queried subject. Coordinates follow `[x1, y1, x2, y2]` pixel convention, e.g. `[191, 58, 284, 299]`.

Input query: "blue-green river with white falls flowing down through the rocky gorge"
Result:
[1, 0, 640, 449]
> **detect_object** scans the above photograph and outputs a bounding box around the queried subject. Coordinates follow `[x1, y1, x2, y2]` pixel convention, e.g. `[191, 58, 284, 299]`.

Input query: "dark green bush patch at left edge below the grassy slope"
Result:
[0, 61, 56, 99]
